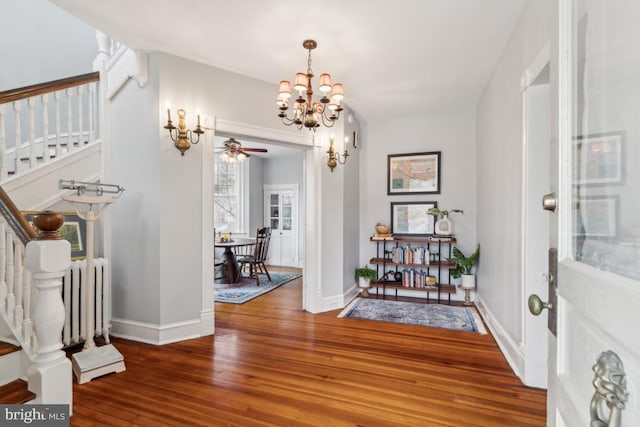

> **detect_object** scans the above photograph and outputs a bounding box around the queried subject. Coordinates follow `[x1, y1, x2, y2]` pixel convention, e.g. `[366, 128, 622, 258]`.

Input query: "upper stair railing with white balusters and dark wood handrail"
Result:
[0, 72, 100, 182]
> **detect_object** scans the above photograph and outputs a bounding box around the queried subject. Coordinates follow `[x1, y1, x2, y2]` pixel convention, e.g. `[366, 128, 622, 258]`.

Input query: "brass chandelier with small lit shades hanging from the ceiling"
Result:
[277, 40, 344, 132]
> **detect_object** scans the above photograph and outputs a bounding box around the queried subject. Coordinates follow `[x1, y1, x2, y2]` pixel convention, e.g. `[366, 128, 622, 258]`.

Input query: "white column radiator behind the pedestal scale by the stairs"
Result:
[62, 258, 111, 347]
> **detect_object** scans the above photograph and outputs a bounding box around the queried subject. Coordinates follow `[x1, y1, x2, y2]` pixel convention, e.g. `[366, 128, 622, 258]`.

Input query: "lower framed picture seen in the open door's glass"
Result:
[573, 196, 619, 237]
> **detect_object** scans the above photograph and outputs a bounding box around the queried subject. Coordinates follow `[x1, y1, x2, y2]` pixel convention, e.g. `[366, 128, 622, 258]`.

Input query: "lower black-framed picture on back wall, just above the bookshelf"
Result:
[391, 202, 438, 236]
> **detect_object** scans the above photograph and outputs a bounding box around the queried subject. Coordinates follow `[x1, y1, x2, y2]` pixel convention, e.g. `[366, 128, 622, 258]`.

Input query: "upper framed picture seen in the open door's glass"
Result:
[573, 132, 624, 185]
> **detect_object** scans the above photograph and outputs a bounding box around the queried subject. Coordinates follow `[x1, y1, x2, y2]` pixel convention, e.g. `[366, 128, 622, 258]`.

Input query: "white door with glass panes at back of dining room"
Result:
[264, 185, 298, 267]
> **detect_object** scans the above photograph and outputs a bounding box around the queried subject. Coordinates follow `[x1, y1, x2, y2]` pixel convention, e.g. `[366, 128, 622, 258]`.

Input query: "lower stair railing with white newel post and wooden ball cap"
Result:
[0, 187, 73, 405]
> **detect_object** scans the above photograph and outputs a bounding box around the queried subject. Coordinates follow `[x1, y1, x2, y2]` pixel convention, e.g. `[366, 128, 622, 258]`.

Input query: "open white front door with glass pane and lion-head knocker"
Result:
[547, 0, 640, 427]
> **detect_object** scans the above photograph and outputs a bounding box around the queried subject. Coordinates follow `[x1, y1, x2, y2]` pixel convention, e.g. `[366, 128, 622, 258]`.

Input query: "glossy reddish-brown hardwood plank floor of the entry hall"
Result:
[71, 270, 546, 427]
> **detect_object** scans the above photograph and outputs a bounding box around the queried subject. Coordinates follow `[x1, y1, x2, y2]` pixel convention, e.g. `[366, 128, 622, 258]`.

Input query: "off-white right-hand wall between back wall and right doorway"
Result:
[476, 0, 556, 374]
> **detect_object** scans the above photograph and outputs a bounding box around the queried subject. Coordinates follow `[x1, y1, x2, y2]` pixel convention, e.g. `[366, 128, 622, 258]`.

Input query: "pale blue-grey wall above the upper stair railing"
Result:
[0, 0, 98, 91]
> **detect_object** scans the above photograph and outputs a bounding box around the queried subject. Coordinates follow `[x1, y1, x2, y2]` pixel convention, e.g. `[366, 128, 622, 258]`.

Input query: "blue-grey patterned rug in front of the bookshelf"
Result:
[338, 298, 487, 334]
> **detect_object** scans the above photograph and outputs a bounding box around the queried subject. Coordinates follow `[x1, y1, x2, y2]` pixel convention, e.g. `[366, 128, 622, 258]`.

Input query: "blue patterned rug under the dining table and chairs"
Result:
[215, 272, 302, 304]
